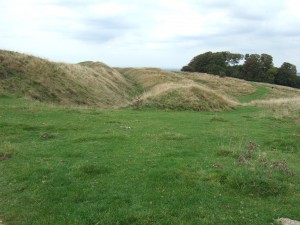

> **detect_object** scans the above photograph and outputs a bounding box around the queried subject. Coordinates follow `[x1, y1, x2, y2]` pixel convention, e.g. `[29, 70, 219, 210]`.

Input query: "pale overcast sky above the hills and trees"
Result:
[0, 0, 300, 71]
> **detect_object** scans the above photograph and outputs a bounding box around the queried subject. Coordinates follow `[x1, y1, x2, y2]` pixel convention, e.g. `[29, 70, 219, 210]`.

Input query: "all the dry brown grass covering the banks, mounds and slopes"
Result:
[0, 50, 300, 112]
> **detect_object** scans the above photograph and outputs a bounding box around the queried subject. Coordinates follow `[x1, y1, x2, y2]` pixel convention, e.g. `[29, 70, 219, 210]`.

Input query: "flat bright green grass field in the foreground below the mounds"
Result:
[0, 94, 300, 225]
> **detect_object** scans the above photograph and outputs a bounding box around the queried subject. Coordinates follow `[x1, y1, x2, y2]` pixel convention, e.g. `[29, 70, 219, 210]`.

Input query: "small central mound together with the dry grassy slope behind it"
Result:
[119, 68, 255, 111]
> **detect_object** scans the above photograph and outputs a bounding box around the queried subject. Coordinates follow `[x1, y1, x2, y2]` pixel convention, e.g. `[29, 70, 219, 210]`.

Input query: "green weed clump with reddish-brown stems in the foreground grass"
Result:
[225, 141, 296, 197]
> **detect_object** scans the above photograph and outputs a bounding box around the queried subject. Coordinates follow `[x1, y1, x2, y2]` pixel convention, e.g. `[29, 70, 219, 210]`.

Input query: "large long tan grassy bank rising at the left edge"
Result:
[0, 51, 132, 108]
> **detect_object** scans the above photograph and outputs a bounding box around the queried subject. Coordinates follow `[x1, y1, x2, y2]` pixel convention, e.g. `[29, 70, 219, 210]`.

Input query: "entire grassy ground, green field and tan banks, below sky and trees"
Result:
[0, 51, 300, 225]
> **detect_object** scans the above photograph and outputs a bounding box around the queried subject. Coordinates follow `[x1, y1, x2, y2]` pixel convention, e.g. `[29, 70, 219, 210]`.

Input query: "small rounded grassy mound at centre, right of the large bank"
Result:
[142, 84, 235, 111]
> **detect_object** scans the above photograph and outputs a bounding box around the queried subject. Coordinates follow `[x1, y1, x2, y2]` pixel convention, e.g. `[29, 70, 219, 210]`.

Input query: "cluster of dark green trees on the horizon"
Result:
[181, 52, 300, 88]
